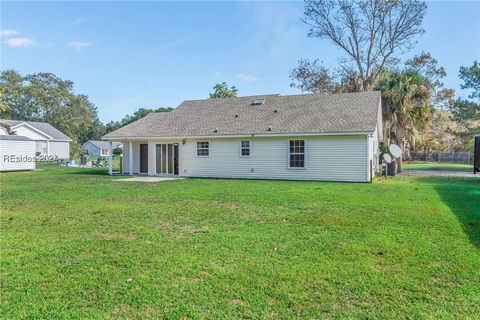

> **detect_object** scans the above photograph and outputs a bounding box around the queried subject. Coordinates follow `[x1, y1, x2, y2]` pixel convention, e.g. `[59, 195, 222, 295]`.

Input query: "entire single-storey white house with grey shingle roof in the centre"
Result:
[103, 92, 383, 182]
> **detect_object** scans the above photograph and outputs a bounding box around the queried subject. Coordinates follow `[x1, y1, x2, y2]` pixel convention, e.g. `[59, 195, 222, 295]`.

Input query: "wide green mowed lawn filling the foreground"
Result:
[0, 166, 480, 319]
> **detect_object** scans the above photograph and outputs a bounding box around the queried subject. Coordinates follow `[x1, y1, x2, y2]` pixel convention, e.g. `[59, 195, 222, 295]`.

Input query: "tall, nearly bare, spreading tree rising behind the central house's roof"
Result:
[291, 0, 427, 92]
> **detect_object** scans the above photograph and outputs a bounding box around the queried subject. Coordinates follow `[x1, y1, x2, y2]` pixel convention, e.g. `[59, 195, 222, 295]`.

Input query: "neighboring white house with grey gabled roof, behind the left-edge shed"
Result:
[0, 120, 72, 159]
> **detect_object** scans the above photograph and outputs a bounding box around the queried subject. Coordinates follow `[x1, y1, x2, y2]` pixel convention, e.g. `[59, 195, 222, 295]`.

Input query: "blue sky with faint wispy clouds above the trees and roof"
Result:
[0, 1, 480, 122]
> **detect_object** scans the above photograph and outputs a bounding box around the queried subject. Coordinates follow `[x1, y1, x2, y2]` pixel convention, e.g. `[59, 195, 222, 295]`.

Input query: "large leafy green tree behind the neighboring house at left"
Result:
[0, 70, 102, 153]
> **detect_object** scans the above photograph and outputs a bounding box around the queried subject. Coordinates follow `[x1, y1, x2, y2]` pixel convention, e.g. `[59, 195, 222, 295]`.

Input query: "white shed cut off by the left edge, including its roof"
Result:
[0, 133, 35, 172]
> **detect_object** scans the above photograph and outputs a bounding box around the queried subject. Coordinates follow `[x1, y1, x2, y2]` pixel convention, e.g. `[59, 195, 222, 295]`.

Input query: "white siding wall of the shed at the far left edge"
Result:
[0, 140, 35, 171]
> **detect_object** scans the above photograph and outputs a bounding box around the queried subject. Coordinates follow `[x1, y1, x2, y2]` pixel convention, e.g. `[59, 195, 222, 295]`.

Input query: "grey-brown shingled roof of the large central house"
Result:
[103, 91, 381, 139]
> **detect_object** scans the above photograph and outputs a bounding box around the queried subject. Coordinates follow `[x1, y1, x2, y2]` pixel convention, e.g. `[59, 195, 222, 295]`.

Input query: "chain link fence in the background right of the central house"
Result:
[402, 150, 473, 164]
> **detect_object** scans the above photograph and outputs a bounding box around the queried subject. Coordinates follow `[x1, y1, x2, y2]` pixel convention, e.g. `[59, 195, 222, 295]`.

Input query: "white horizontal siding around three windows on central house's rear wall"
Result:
[179, 135, 368, 182]
